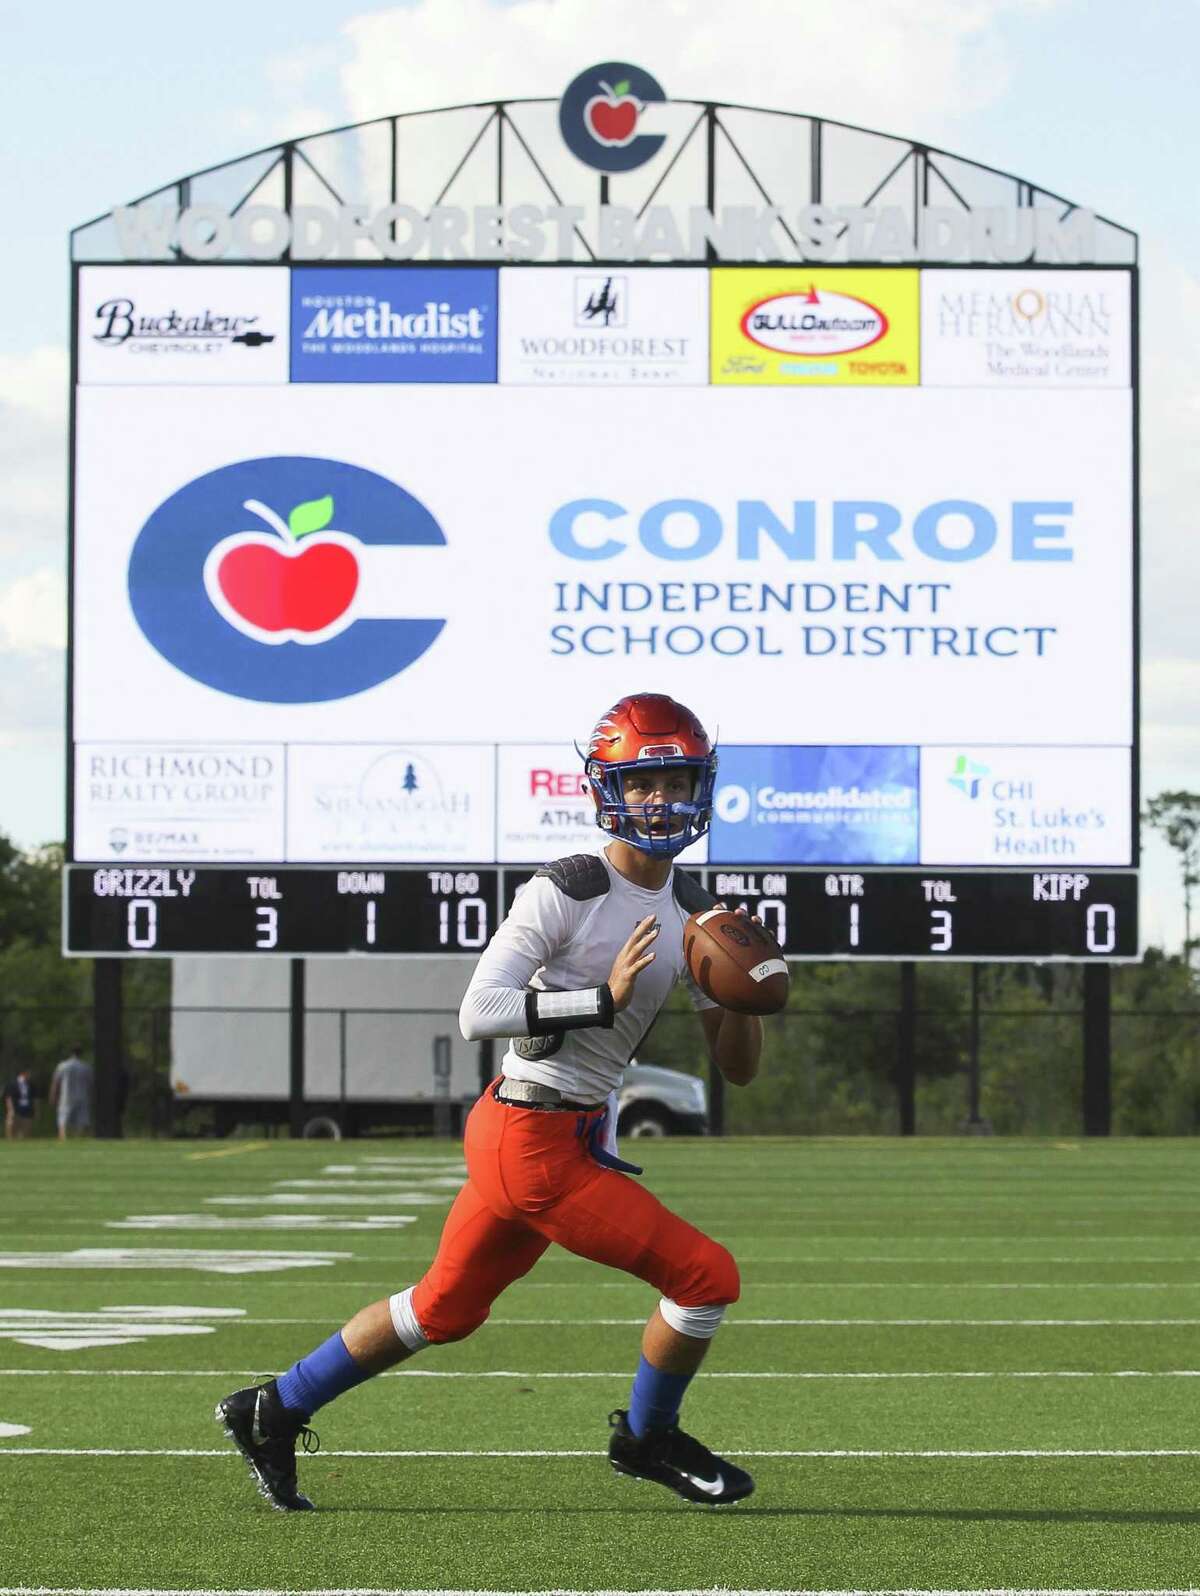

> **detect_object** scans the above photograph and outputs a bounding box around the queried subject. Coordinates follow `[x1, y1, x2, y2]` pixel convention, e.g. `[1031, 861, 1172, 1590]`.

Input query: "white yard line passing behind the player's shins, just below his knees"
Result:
[0, 1368, 1200, 1384]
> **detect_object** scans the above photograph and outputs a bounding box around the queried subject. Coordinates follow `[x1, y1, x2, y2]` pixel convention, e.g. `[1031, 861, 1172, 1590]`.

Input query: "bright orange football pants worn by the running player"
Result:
[412, 1080, 740, 1342]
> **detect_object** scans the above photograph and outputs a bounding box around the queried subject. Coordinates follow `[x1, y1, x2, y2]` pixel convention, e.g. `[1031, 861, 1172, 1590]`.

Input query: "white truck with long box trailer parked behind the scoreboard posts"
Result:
[171, 958, 709, 1136]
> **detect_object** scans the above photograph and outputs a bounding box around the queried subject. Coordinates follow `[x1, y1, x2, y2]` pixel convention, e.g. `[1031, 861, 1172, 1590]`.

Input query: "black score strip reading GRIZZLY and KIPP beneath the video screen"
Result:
[64, 865, 1138, 961]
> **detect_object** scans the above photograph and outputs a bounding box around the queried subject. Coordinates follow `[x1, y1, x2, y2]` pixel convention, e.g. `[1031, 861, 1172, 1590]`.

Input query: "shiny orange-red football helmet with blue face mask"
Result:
[582, 693, 716, 857]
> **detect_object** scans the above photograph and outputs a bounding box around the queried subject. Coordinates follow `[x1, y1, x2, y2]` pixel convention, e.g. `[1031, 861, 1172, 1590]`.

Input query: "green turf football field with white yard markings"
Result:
[0, 1140, 1200, 1593]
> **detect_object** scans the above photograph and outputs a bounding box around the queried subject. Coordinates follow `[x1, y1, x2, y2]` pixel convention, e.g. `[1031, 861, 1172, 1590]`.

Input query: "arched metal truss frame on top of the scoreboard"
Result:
[72, 99, 1138, 267]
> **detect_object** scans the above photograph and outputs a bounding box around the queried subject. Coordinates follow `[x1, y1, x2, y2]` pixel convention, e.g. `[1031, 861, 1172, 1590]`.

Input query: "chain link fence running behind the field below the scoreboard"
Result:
[0, 1005, 1200, 1136]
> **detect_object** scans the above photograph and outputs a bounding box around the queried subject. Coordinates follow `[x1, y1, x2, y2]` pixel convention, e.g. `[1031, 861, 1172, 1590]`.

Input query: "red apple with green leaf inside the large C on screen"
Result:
[204, 493, 362, 643]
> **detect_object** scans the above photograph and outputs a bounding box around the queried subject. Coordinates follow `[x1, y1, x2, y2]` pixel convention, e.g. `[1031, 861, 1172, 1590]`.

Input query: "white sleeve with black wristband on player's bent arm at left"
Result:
[458, 876, 613, 1042]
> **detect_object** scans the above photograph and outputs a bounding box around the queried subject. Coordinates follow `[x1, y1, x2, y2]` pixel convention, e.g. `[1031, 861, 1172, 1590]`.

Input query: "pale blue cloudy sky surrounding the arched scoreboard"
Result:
[0, 0, 1200, 940]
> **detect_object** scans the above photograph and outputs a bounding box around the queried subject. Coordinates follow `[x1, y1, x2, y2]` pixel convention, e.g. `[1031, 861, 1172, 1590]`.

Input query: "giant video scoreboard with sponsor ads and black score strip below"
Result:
[64, 140, 1139, 959]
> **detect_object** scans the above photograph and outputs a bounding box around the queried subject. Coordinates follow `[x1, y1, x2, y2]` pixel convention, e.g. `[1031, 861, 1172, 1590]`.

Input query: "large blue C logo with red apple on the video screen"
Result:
[126, 453, 450, 702]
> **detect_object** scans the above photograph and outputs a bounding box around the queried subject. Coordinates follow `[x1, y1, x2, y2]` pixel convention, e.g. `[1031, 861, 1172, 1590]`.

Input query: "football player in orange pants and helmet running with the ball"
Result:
[217, 693, 763, 1510]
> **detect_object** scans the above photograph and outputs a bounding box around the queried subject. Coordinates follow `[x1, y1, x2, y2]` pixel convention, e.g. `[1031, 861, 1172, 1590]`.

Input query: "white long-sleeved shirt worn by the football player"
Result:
[458, 854, 716, 1103]
